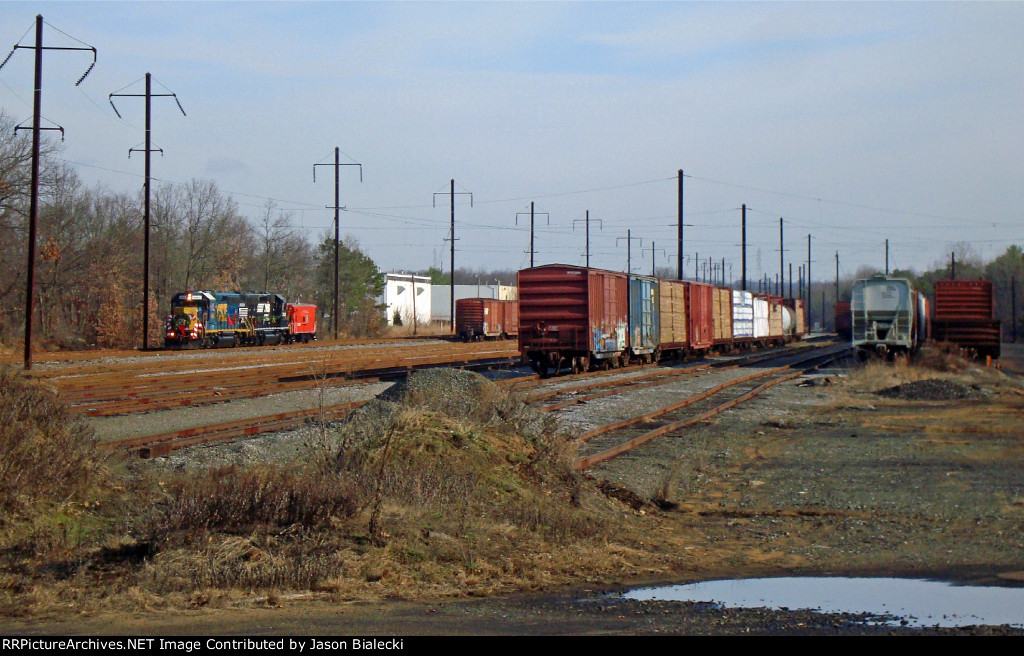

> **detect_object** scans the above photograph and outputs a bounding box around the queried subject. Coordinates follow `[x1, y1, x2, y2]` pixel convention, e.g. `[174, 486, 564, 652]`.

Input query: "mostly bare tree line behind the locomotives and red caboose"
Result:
[0, 108, 384, 348]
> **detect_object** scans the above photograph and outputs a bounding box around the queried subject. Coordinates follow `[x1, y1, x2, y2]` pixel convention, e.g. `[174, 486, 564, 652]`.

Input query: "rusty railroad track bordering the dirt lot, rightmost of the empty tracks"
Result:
[573, 345, 850, 470]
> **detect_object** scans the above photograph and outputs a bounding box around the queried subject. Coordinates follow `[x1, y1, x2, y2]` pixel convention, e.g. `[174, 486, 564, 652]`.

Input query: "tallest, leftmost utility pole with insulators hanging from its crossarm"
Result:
[0, 14, 96, 370]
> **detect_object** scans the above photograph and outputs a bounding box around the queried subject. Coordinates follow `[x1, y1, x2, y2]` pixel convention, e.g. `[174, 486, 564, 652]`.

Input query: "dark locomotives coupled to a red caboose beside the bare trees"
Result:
[164, 292, 316, 348]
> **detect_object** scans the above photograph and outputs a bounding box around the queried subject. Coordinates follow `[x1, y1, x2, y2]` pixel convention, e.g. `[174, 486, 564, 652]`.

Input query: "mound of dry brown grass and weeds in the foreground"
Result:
[0, 366, 640, 615]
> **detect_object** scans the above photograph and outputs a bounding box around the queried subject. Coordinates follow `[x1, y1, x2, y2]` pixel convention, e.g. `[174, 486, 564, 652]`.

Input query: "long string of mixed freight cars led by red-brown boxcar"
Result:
[518, 264, 805, 375]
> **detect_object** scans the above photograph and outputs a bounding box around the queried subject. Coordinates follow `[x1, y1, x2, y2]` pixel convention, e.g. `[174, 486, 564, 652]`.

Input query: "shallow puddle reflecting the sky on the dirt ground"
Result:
[623, 577, 1024, 627]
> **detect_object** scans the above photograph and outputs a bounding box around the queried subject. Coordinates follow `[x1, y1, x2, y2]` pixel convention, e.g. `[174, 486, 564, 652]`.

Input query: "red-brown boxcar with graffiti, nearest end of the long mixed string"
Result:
[519, 264, 629, 374]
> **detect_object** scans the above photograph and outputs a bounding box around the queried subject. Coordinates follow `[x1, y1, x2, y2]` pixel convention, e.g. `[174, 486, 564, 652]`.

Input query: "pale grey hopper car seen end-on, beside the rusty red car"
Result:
[850, 275, 928, 359]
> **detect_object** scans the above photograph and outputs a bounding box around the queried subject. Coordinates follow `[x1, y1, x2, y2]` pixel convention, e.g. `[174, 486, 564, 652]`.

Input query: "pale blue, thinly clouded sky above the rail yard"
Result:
[0, 2, 1024, 278]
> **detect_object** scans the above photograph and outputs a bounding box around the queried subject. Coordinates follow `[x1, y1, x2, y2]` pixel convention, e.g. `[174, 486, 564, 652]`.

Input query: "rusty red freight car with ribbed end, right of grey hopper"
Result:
[932, 280, 1001, 358]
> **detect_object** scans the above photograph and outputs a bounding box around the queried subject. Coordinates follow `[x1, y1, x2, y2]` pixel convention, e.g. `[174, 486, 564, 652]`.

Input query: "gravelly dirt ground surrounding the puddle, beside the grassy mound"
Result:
[0, 339, 1024, 636]
